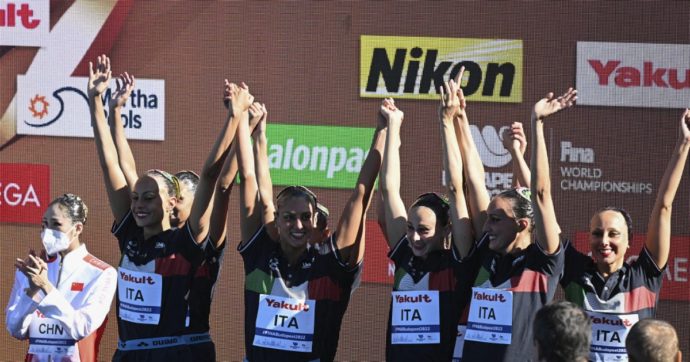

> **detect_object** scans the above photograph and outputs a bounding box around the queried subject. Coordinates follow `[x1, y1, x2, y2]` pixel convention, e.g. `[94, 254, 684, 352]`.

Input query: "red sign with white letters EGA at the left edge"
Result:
[0, 163, 50, 225]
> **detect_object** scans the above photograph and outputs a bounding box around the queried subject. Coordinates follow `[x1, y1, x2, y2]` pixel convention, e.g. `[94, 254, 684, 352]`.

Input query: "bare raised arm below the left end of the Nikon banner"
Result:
[379, 98, 407, 249]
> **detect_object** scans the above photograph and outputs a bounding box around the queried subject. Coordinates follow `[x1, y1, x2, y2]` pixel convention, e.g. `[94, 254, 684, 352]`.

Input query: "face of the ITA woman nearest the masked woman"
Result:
[131, 175, 176, 228]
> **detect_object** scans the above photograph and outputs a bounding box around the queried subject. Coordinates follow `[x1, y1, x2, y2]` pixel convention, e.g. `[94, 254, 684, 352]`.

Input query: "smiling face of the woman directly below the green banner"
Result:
[276, 196, 316, 252]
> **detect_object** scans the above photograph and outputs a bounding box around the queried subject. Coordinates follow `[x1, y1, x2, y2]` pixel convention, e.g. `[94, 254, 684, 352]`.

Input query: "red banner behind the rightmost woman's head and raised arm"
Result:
[575, 232, 690, 301]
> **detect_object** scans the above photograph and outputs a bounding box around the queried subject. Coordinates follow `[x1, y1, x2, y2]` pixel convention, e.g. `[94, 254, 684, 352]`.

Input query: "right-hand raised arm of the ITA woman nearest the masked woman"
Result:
[189, 79, 251, 242]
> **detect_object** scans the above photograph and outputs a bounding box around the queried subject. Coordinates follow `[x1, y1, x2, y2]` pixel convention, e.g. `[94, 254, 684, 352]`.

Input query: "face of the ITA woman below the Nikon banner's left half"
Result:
[407, 206, 448, 259]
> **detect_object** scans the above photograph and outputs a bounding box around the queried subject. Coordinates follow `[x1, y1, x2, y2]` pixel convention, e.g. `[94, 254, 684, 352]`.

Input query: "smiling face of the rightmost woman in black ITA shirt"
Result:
[589, 210, 629, 274]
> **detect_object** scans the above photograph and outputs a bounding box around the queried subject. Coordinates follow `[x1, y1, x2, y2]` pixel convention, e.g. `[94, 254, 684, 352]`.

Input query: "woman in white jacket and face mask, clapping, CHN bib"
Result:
[5, 194, 117, 361]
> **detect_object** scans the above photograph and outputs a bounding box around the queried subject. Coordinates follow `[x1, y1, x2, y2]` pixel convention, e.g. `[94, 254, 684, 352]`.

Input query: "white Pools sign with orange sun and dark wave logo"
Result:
[17, 76, 165, 141]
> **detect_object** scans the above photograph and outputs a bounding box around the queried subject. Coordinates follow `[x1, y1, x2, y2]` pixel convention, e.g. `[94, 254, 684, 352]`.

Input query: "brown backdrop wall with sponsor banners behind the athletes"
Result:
[0, 0, 690, 361]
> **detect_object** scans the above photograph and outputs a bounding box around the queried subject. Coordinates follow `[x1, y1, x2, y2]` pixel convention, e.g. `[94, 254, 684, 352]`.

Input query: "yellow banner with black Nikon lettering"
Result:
[359, 35, 522, 103]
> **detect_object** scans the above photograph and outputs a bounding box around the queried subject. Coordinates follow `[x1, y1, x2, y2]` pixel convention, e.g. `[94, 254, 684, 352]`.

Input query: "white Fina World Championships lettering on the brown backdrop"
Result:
[560, 141, 652, 194]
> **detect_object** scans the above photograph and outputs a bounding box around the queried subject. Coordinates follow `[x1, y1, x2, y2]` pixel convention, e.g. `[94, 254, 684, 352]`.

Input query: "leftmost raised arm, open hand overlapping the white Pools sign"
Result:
[87, 55, 131, 224]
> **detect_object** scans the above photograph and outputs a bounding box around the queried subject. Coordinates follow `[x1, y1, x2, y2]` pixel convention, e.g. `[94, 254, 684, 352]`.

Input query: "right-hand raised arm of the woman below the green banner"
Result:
[335, 101, 387, 266]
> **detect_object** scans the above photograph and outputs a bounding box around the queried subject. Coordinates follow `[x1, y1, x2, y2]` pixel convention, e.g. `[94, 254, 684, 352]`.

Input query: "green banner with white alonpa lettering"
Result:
[266, 124, 374, 189]
